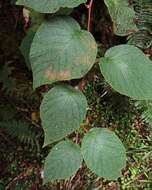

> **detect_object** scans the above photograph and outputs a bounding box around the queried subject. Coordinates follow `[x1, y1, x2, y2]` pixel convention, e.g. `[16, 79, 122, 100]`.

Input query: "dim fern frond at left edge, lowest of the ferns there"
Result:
[0, 120, 37, 147]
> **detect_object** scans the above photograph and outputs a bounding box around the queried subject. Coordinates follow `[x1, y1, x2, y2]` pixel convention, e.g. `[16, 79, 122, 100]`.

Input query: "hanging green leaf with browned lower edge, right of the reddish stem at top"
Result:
[104, 0, 138, 36]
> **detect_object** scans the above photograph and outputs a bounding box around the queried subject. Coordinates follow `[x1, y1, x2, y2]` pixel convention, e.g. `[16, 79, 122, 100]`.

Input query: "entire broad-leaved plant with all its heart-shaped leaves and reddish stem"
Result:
[17, 0, 152, 183]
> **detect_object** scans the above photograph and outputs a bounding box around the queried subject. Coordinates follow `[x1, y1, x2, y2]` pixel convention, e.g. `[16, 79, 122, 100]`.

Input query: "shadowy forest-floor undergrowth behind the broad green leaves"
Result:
[0, 0, 152, 190]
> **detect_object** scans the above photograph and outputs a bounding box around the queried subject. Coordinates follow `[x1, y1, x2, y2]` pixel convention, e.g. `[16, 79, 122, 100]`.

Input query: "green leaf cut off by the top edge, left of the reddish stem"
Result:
[16, 0, 87, 13]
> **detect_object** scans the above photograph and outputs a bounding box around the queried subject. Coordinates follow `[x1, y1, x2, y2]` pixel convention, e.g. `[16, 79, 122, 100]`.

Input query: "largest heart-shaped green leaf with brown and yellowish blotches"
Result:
[30, 16, 97, 87]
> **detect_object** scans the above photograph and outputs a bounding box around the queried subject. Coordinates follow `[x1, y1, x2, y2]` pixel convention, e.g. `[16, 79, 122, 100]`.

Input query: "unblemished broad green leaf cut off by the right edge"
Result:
[100, 45, 152, 100]
